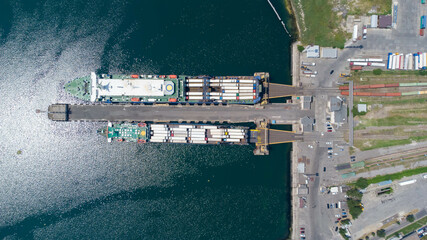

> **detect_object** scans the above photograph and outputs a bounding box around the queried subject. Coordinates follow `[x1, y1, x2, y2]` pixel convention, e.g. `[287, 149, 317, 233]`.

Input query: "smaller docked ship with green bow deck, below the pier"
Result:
[98, 122, 251, 145]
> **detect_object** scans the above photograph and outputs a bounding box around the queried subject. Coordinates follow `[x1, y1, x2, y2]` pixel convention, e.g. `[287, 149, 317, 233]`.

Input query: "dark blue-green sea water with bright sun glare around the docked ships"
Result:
[0, 0, 290, 239]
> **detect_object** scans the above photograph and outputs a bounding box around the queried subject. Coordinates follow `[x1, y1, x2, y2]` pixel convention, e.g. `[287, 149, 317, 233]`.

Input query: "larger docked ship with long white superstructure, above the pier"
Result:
[65, 72, 269, 104]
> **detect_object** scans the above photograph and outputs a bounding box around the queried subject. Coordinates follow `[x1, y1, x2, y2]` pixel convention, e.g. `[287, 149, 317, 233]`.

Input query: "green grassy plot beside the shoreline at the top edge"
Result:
[291, 0, 350, 49]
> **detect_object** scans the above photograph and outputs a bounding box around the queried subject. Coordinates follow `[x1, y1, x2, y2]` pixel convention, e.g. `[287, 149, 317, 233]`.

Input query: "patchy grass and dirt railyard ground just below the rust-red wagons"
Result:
[354, 97, 427, 150]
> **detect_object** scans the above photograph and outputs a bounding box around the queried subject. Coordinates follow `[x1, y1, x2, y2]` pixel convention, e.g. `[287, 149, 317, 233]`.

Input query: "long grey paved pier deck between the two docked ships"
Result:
[69, 103, 314, 124]
